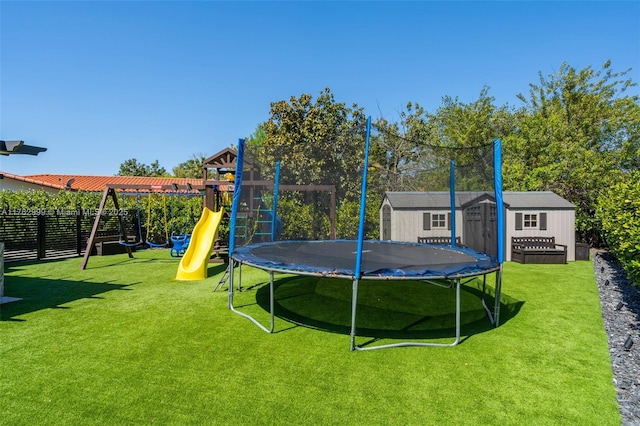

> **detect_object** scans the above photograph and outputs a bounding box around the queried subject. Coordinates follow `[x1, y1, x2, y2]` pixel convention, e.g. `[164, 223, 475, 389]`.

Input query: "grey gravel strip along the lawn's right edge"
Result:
[593, 252, 640, 426]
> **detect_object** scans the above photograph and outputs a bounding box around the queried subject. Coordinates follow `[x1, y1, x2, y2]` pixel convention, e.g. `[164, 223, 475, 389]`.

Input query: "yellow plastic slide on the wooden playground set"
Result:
[176, 207, 224, 281]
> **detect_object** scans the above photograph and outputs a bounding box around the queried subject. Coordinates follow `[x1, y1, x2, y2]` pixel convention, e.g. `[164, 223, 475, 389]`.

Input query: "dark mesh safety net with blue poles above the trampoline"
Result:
[231, 118, 503, 261]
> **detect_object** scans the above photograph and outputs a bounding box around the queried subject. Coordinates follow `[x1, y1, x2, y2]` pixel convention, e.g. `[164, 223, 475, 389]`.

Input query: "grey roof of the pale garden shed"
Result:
[385, 191, 575, 209]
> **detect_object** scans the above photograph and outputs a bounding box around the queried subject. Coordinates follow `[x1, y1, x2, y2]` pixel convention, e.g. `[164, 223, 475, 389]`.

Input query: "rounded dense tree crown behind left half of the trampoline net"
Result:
[254, 88, 366, 201]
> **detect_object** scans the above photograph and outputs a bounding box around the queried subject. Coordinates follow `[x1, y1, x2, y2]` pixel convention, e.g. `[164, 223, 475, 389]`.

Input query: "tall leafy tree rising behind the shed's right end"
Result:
[504, 61, 640, 245]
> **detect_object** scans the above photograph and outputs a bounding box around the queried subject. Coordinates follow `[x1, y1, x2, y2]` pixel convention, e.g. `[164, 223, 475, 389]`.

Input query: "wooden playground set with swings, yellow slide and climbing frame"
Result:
[80, 148, 318, 280]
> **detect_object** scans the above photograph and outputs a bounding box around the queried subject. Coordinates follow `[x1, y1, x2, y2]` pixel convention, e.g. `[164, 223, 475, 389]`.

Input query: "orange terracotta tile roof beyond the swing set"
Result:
[13, 173, 202, 192]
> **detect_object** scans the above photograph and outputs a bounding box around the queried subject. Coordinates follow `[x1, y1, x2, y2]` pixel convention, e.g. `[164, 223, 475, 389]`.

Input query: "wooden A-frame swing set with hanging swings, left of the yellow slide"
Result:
[80, 183, 200, 270]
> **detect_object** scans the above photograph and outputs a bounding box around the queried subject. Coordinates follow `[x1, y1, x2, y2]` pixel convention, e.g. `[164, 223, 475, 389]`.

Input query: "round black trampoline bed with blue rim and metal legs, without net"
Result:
[229, 240, 501, 350]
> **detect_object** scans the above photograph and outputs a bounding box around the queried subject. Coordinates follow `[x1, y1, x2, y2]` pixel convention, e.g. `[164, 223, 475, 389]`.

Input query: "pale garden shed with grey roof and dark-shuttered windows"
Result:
[380, 191, 576, 261]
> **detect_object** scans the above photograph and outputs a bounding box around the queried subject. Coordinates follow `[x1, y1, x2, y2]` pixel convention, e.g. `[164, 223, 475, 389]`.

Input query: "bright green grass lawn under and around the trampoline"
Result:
[0, 250, 620, 426]
